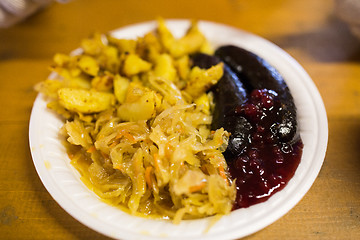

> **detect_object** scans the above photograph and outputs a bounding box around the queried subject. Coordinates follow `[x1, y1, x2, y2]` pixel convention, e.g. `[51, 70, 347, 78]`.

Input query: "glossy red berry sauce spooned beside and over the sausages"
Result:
[229, 89, 303, 209]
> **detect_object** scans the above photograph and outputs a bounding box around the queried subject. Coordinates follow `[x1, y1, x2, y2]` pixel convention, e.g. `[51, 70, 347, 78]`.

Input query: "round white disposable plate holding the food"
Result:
[29, 20, 328, 239]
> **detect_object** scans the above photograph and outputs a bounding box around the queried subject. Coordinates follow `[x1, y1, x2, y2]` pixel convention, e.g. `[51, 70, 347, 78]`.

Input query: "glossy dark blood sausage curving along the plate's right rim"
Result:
[215, 45, 298, 143]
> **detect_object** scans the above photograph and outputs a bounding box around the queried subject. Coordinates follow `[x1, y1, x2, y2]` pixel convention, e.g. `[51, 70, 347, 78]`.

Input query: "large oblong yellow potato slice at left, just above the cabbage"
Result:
[58, 88, 115, 113]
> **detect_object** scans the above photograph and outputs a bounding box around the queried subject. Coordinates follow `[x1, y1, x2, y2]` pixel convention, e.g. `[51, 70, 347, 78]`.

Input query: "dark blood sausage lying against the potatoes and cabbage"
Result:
[192, 53, 252, 158]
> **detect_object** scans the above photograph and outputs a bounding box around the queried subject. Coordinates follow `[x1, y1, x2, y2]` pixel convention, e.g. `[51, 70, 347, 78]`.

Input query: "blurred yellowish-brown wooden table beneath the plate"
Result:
[0, 0, 360, 240]
